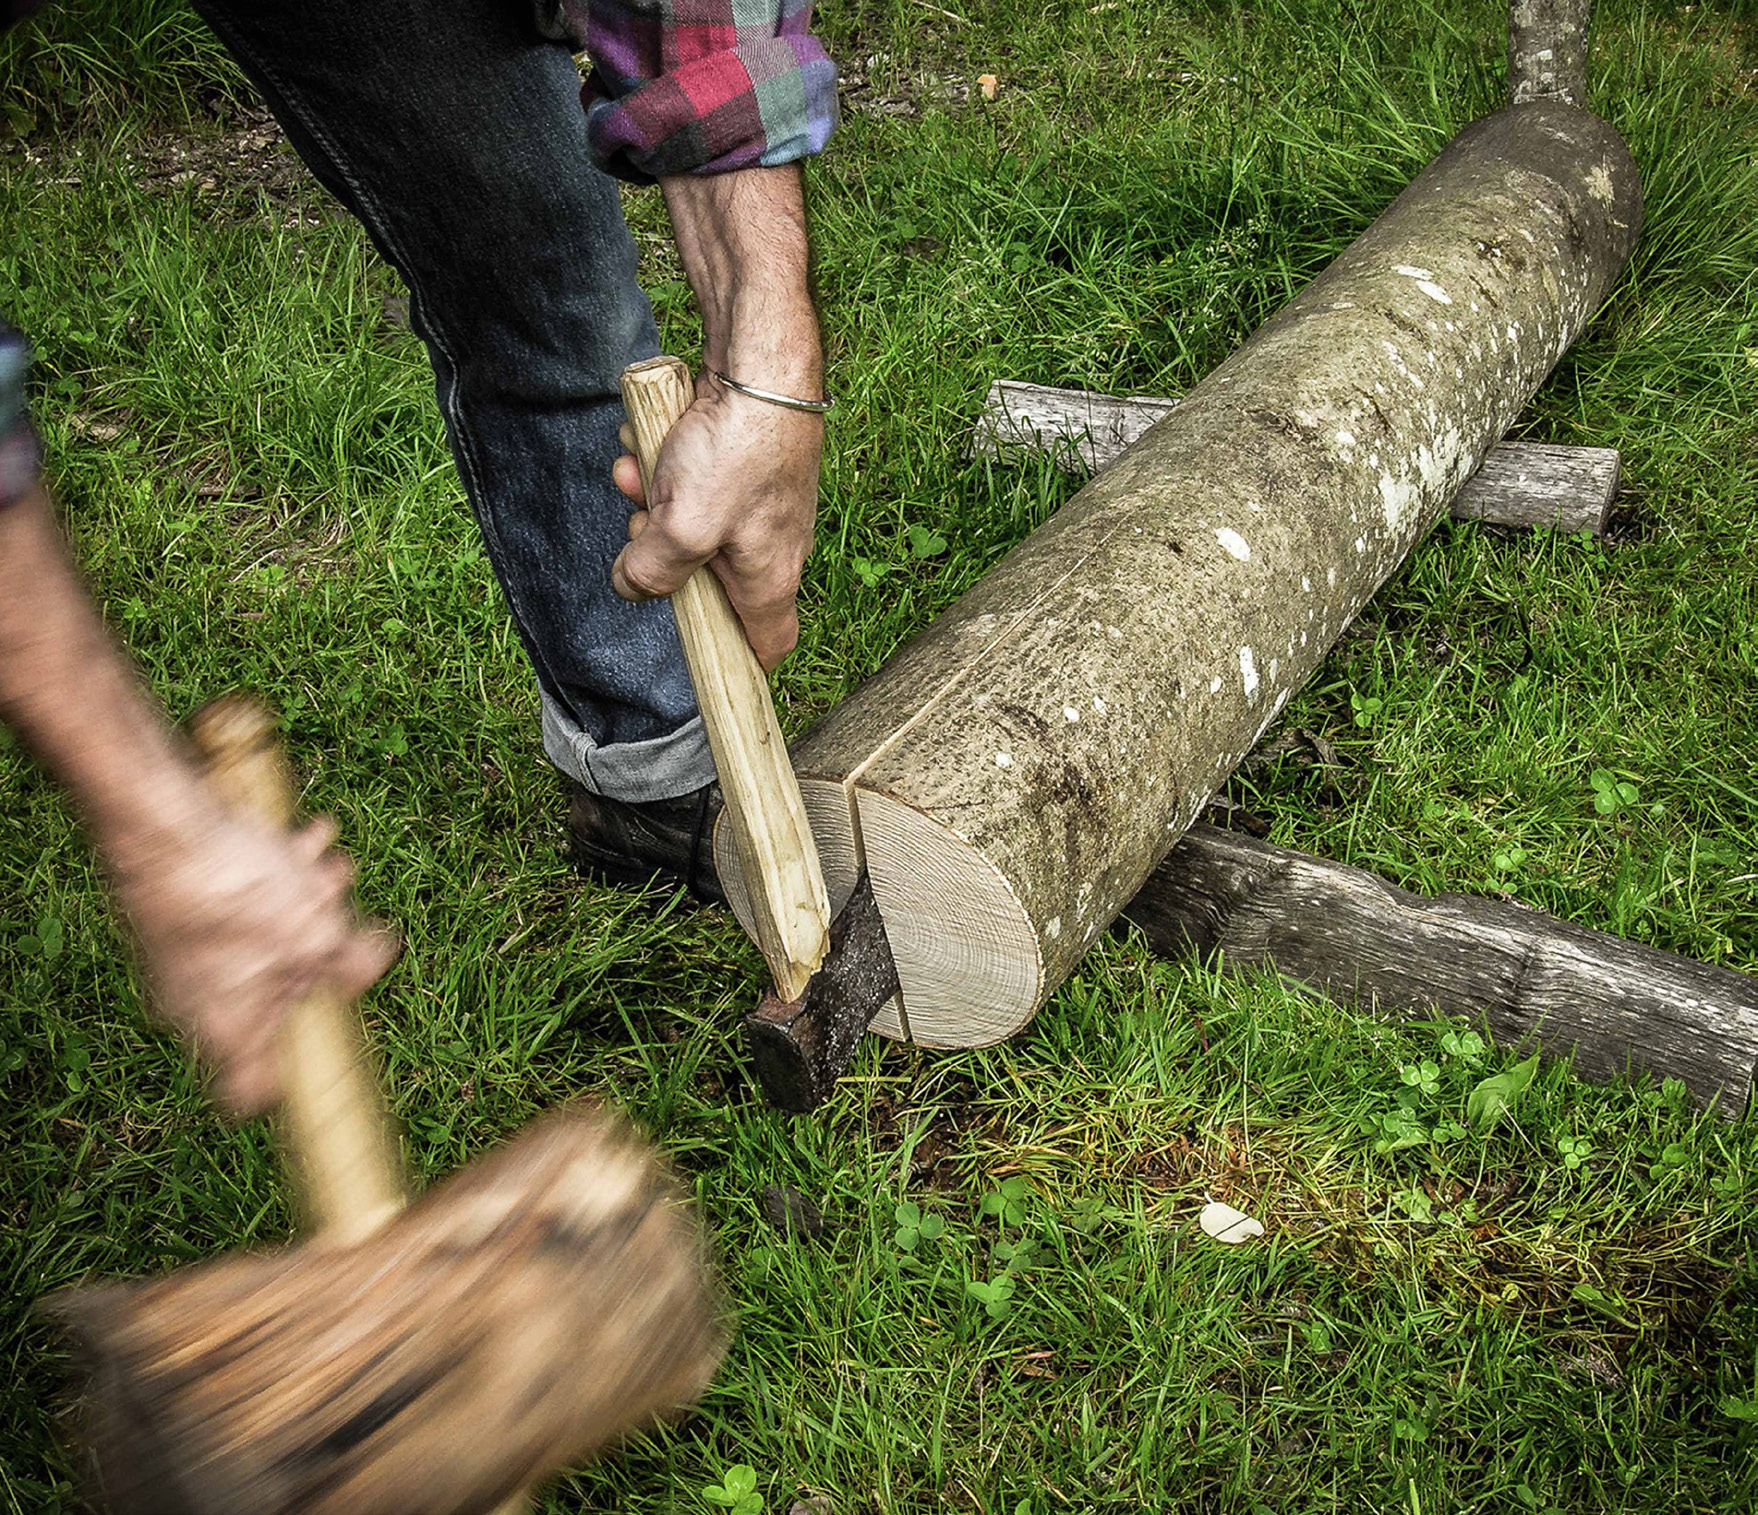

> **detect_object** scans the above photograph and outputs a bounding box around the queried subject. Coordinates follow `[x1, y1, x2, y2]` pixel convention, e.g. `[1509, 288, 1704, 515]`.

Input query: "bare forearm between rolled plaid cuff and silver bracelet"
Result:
[661, 163, 825, 399]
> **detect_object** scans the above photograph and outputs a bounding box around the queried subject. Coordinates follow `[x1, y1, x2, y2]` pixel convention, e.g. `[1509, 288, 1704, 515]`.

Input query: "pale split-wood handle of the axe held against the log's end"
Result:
[622, 357, 830, 1000]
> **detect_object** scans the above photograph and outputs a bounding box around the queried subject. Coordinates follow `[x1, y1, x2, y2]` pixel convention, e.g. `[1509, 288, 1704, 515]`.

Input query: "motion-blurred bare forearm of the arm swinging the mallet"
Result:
[0, 487, 204, 870]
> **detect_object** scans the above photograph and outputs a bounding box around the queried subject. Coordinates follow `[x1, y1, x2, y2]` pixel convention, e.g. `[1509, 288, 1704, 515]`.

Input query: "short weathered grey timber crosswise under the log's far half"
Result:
[970, 380, 1619, 536]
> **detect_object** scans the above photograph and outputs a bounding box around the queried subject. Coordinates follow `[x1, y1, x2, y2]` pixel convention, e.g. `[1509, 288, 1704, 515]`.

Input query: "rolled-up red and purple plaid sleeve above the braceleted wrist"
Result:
[547, 0, 837, 183]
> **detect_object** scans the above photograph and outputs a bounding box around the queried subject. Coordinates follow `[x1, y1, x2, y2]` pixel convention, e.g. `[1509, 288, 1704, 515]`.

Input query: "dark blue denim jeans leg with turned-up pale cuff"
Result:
[197, 0, 714, 800]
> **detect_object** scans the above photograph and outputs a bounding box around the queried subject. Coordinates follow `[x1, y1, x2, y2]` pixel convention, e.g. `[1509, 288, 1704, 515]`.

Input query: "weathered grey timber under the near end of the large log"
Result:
[1123, 824, 1758, 1120]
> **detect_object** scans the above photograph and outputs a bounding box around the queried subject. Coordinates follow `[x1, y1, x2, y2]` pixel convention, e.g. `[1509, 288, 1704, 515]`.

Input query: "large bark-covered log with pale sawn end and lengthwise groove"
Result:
[716, 102, 1642, 1047]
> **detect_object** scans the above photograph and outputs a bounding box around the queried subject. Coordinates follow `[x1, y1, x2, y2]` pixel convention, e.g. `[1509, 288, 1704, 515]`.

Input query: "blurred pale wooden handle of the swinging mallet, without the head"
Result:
[188, 694, 406, 1243]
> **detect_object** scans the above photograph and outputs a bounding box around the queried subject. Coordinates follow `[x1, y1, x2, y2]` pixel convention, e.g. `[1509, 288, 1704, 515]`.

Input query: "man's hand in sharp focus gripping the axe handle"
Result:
[610, 378, 825, 670]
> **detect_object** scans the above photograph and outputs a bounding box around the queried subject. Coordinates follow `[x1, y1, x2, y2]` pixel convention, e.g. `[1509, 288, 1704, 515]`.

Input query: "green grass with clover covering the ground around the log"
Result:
[0, 0, 1758, 1515]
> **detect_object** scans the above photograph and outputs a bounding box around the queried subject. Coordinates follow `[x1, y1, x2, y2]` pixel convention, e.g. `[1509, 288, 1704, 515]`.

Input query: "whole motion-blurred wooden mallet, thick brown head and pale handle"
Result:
[47, 703, 724, 1515]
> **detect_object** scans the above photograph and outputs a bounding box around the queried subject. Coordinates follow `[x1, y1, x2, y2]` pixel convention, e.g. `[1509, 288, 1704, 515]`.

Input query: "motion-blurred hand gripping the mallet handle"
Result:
[116, 808, 397, 1114]
